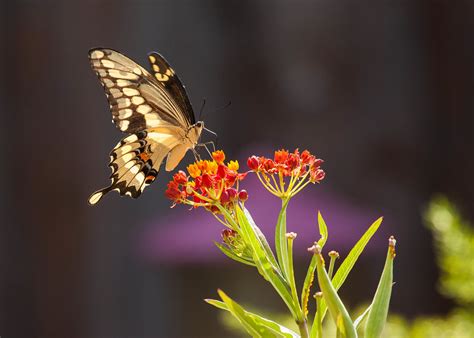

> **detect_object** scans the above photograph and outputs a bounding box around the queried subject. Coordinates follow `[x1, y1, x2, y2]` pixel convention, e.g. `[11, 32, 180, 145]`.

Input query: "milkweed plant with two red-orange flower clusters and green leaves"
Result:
[166, 149, 396, 338]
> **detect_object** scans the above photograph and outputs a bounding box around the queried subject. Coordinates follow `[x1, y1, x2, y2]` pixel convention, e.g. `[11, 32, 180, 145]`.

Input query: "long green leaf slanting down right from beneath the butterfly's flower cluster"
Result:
[235, 206, 301, 319]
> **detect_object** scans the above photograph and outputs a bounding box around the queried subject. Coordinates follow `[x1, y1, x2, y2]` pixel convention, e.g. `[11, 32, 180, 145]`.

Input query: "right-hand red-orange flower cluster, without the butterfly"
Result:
[247, 149, 325, 199]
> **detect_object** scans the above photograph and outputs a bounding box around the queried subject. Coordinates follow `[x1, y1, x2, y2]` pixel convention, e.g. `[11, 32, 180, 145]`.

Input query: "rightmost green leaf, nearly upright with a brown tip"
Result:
[364, 237, 395, 338]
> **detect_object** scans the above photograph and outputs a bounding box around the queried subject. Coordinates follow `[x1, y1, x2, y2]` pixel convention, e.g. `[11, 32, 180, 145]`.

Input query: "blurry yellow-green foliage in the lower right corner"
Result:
[384, 196, 474, 338]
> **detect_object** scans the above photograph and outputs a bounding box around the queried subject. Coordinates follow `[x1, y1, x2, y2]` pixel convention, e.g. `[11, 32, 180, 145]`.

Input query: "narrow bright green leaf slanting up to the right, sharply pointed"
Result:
[318, 217, 383, 320]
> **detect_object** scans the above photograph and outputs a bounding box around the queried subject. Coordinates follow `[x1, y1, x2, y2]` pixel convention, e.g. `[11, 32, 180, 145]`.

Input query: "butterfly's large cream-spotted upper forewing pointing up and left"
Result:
[89, 48, 194, 133]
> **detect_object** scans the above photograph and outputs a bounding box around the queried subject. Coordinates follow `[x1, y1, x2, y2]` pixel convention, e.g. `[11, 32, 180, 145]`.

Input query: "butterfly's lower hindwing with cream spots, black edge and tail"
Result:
[89, 127, 189, 205]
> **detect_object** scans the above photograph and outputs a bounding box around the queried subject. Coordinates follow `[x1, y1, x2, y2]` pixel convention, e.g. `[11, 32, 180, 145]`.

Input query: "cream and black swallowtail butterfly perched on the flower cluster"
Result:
[89, 48, 207, 205]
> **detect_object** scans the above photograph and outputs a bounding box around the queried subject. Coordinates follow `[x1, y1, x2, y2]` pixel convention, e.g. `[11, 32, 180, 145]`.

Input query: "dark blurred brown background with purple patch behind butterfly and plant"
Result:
[0, 0, 474, 337]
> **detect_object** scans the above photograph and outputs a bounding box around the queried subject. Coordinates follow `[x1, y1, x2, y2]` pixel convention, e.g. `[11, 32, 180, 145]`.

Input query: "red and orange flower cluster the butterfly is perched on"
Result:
[165, 150, 248, 213]
